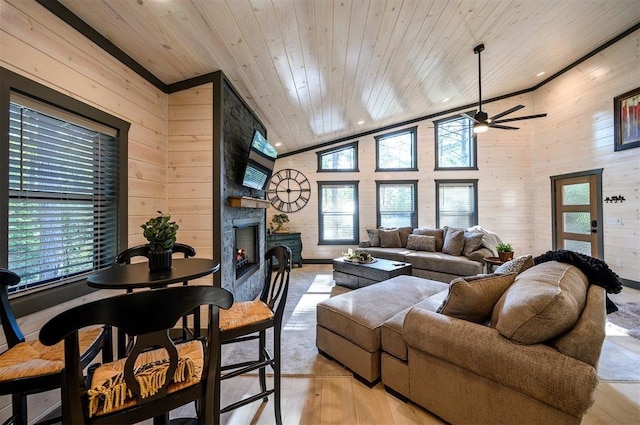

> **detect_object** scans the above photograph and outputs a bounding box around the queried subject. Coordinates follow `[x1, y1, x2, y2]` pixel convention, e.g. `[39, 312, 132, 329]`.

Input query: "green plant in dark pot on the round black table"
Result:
[140, 211, 178, 271]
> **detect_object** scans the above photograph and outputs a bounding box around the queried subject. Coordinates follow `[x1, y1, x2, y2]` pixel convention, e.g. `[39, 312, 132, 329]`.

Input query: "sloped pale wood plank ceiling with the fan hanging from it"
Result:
[51, 0, 640, 153]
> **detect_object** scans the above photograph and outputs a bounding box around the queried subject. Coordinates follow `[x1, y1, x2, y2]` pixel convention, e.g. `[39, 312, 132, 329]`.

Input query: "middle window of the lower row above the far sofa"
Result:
[376, 180, 418, 227]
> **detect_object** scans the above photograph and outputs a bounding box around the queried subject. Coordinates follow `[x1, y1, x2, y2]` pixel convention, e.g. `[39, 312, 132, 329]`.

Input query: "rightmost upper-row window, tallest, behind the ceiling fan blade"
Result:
[434, 115, 477, 170]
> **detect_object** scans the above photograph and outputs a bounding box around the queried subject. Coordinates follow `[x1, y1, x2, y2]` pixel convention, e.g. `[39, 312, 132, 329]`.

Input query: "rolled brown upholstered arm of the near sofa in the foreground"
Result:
[403, 308, 598, 417]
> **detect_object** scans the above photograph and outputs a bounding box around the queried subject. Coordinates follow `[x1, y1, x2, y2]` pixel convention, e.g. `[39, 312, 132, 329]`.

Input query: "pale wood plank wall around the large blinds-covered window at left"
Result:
[0, 0, 168, 422]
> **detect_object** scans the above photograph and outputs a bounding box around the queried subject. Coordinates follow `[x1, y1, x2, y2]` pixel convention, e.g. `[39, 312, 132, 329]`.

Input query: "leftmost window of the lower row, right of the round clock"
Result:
[318, 181, 359, 245]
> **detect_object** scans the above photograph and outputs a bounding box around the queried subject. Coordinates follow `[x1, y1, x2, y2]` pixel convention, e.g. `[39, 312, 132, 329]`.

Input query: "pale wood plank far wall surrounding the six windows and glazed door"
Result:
[268, 32, 640, 282]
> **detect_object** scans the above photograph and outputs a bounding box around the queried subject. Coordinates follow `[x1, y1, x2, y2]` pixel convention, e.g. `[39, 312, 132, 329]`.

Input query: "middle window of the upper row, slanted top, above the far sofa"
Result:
[375, 127, 418, 171]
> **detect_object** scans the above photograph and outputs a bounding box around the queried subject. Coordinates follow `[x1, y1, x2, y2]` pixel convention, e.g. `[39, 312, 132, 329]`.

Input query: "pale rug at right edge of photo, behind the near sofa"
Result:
[598, 339, 640, 381]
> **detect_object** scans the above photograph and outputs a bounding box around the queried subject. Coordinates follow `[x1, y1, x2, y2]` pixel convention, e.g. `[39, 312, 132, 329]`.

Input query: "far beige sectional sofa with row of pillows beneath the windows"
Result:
[358, 226, 500, 283]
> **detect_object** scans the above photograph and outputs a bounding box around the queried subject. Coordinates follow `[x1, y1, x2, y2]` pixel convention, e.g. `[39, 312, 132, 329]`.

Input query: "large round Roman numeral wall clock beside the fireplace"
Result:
[267, 168, 311, 213]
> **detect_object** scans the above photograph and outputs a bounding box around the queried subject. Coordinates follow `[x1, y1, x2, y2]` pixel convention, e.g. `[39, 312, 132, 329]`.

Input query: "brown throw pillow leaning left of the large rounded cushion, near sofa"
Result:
[438, 273, 516, 323]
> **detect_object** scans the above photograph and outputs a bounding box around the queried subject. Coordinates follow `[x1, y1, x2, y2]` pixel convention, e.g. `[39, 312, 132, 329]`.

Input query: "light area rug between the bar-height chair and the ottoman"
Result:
[222, 268, 351, 376]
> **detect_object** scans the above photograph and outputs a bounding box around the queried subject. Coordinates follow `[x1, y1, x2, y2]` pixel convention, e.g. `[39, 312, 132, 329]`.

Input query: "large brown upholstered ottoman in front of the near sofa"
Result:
[316, 276, 448, 385]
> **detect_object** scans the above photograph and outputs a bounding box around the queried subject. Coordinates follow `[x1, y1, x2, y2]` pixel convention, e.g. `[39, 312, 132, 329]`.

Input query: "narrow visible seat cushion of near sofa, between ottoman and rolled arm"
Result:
[380, 282, 449, 361]
